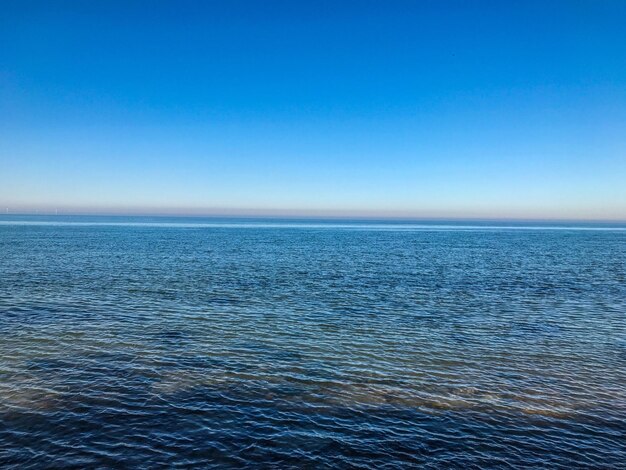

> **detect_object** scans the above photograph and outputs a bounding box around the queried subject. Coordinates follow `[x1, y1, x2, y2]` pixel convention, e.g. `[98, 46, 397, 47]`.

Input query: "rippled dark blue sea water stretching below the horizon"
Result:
[0, 216, 626, 469]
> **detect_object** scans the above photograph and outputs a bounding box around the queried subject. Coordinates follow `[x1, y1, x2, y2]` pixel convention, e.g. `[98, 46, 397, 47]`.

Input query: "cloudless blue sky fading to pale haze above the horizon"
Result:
[0, 0, 626, 220]
